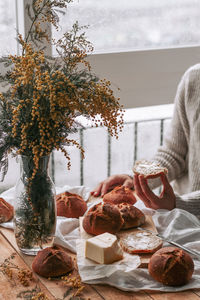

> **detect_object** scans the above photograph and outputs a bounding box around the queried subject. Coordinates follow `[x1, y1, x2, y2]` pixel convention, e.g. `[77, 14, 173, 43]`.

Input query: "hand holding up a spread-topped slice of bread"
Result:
[134, 173, 176, 210]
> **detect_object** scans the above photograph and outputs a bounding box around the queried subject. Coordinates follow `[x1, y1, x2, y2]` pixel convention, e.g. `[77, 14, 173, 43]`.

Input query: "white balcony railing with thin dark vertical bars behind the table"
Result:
[0, 105, 173, 191]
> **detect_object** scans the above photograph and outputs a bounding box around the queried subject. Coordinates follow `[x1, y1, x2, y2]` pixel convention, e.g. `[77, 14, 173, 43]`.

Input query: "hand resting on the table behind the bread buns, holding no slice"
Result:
[91, 174, 133, 197]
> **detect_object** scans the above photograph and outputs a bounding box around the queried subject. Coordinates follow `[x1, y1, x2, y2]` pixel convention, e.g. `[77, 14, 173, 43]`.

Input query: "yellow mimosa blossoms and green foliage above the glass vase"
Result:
[0, 0, 123, 179]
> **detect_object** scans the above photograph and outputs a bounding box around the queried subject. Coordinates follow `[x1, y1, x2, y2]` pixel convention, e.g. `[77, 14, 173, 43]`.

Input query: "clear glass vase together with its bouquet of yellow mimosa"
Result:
[0, 0, 123, 254]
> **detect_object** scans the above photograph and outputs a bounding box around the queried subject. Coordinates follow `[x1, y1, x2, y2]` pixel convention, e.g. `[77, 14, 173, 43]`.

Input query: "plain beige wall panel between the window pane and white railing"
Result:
[89, 47, 200, 108]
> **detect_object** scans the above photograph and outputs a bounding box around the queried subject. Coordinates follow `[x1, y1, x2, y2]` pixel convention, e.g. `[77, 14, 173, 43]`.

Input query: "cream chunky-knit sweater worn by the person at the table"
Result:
[154, 64, 200, 217]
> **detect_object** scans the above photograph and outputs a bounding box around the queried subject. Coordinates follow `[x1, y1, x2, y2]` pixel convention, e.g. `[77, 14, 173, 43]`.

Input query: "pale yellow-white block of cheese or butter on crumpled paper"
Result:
[85, 232, 123, 264]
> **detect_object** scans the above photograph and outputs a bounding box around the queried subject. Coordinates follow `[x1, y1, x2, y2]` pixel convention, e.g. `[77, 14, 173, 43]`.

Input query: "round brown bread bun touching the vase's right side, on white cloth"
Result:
[56, 192, 87, 218]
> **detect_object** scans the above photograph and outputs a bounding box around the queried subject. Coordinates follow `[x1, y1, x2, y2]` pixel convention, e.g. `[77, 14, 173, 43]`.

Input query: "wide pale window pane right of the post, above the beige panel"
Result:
[53, 0, 200, 53]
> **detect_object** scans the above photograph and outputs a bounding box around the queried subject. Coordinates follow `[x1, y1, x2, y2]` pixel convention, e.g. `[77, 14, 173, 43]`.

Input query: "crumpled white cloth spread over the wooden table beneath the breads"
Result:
[1, 186, 200, 292]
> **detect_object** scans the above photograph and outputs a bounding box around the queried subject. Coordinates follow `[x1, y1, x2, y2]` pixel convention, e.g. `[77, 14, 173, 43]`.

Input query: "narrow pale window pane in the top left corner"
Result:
[0, 0, 17, 56]
